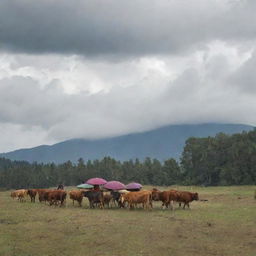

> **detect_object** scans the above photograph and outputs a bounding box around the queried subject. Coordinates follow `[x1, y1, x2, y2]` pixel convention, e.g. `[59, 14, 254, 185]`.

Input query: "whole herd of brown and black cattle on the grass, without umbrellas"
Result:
[11, 188, 199, 210]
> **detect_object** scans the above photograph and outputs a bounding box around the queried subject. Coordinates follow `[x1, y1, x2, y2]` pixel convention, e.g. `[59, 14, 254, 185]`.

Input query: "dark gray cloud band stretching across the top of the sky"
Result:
[0, 0, 256, 56]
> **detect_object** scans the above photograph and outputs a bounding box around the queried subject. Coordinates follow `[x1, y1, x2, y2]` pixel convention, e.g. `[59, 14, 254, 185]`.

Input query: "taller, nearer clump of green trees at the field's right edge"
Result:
[180, 129, 256, 186]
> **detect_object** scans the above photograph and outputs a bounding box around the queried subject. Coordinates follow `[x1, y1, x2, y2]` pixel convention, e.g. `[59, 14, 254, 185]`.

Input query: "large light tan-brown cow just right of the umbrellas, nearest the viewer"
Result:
[120, 191, 152, 209]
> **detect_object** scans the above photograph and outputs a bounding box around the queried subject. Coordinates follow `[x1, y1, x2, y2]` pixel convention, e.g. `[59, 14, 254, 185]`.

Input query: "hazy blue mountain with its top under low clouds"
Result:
[0, 124, 254, 163]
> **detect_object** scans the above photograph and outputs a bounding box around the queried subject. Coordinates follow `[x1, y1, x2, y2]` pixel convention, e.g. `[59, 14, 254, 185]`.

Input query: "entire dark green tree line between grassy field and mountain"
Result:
[0, 129, 256, 189]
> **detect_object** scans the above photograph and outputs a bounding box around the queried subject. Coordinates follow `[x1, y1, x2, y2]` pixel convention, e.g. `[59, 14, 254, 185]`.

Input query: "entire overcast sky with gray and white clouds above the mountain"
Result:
[0, 0, 256, 152]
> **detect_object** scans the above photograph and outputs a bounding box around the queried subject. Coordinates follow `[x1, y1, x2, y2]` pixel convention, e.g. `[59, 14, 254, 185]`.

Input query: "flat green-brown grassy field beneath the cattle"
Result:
[0, 186, 256, 256]
